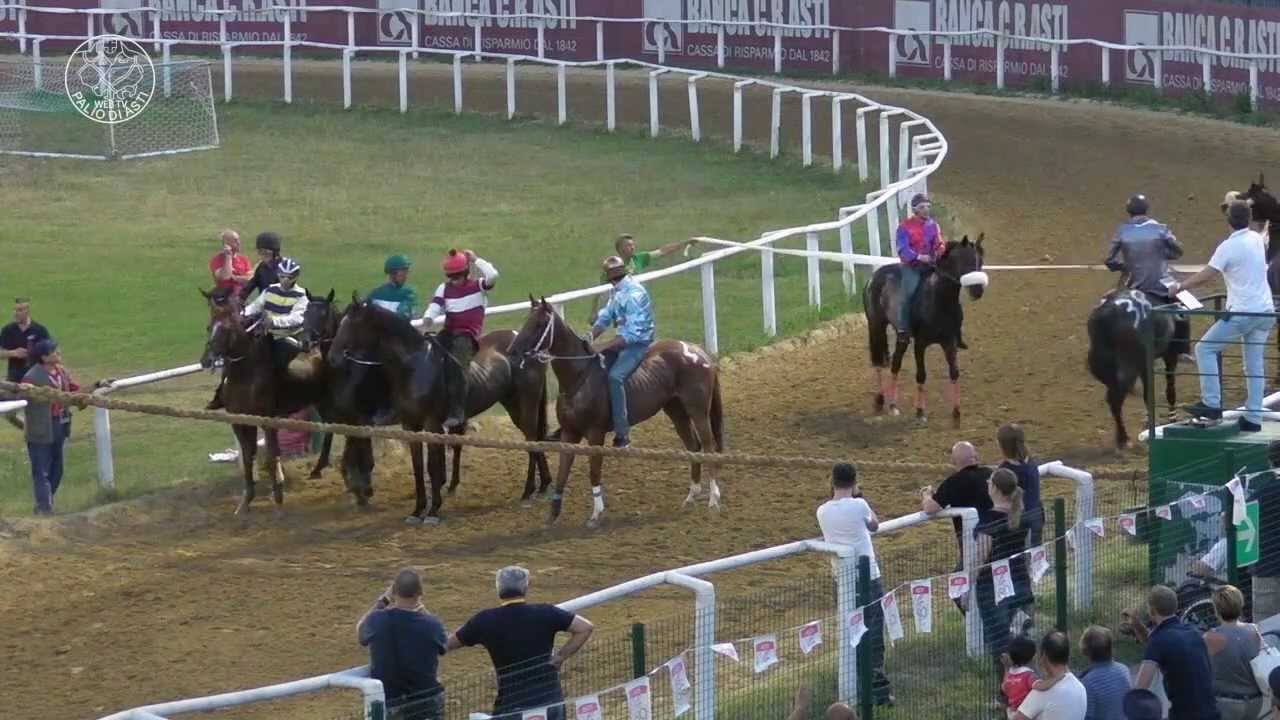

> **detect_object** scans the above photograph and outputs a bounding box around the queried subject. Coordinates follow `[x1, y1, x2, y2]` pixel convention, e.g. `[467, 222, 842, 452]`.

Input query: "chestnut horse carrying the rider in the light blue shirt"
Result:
[511, 297, 724, 528]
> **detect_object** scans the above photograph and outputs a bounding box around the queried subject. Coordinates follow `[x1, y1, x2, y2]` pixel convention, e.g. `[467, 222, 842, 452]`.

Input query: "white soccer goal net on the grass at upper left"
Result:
[0, 58, 219, 160]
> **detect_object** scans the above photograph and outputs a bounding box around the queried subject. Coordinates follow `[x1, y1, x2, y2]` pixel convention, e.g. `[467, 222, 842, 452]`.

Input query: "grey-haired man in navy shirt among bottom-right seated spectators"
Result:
[1134, 585, 1221, 720]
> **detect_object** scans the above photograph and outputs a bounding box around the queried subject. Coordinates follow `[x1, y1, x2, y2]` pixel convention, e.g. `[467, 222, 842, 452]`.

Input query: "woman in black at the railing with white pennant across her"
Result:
[974, 469, 1030, 705]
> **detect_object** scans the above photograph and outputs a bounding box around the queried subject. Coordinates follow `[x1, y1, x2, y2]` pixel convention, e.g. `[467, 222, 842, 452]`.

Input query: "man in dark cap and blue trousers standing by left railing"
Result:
[22, 338, 79, 515]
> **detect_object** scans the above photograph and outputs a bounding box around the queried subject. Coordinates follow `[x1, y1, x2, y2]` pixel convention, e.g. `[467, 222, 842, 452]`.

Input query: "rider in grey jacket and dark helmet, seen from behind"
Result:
[1106, 193, 1192, 355]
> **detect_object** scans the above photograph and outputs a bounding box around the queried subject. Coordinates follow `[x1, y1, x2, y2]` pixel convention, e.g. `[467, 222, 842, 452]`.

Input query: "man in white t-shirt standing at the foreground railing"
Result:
[818, 462, 893, 705]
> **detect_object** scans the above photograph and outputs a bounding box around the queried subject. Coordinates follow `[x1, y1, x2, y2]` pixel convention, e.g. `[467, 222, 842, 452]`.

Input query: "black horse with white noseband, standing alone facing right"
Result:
[863, 233, 987, 423]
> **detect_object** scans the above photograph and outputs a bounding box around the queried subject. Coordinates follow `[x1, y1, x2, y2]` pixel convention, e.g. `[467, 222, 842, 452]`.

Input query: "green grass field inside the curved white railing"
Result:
[0, 102, 867, 516]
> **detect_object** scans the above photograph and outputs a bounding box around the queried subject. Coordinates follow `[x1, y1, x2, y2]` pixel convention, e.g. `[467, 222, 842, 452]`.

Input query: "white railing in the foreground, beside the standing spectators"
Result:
[102, 461, 1093, 720]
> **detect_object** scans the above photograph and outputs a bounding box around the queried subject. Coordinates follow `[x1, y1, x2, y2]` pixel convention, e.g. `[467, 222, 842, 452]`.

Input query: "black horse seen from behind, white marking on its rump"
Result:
[1087, 288, 1180, 450]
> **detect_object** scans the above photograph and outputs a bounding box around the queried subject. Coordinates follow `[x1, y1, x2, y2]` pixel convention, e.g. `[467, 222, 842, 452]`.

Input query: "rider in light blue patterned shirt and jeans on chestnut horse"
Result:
[591, 255, 654, 447]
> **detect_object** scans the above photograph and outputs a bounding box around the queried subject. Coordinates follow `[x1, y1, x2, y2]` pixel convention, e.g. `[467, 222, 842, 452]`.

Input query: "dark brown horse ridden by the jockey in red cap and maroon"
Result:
[328, 296, 550, 524]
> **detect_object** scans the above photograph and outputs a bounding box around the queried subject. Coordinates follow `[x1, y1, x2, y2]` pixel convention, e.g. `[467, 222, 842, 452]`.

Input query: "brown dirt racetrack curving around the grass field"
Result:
[0, 64, 1280, 719]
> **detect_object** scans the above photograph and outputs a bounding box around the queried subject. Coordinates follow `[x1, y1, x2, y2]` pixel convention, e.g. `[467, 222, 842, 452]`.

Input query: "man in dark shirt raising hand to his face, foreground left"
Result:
[356, 568, 445, 720]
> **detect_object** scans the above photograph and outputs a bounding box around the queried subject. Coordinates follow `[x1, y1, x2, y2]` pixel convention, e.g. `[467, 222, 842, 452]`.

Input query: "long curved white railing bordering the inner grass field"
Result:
[0, 11, 948, 489]
